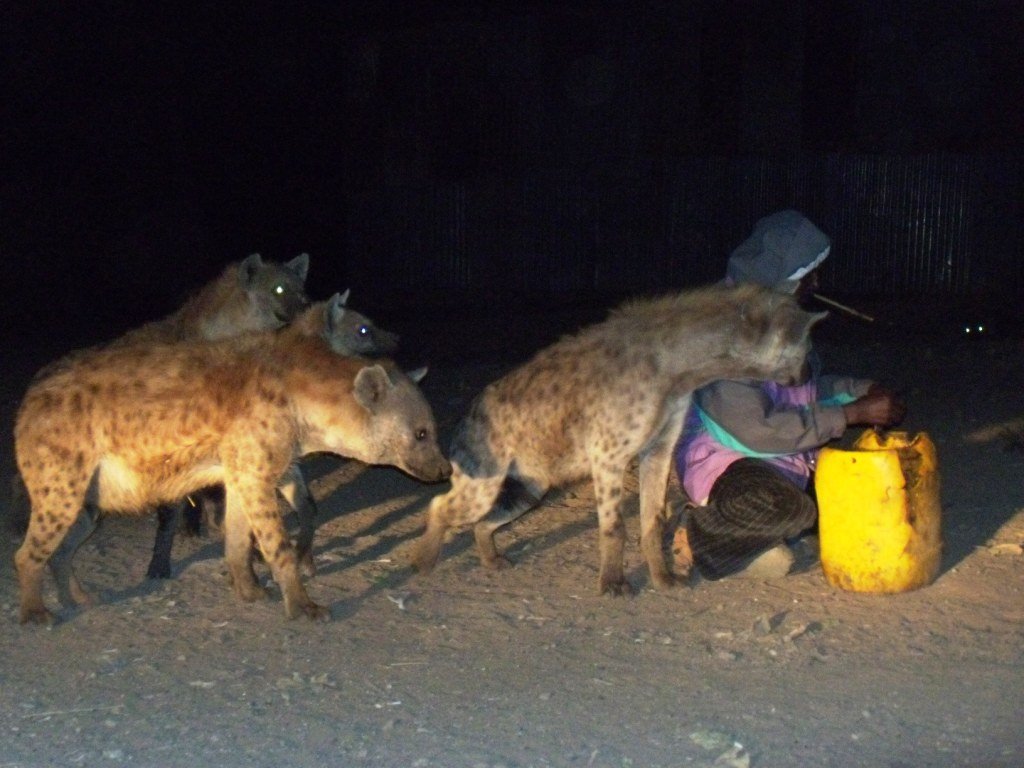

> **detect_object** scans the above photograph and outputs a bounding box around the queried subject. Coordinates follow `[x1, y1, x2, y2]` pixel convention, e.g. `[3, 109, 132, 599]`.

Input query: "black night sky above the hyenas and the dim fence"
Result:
[0, 0, 1024, 342]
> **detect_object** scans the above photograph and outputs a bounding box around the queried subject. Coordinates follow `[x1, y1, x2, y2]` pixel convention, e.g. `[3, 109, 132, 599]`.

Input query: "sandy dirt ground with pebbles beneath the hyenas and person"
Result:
[0, 303, 1024, 768]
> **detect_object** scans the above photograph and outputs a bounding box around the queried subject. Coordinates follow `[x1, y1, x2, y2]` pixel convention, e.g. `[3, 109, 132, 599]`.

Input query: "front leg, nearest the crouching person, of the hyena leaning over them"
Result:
[639, 409, 689, 589]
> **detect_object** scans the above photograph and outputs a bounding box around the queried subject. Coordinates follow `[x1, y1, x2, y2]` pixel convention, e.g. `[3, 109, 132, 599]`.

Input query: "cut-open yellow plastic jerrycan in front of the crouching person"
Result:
[814, 429, 942, 593]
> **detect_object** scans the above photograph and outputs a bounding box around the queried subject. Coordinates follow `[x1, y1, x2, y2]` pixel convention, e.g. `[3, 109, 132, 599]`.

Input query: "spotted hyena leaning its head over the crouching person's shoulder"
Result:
[413, 286, 824, 594]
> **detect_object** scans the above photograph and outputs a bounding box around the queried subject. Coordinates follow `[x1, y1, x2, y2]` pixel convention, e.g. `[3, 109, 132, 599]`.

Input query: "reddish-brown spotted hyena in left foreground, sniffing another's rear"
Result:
[14, 333, 451, 623]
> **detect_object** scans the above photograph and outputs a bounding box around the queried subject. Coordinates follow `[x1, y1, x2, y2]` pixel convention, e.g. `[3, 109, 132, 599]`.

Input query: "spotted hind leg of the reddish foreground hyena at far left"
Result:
[14, 472, 95, 624]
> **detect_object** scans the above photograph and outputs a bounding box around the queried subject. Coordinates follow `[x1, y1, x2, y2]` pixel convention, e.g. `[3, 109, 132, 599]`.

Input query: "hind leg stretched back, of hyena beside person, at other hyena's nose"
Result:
[412, 464, 505, 573]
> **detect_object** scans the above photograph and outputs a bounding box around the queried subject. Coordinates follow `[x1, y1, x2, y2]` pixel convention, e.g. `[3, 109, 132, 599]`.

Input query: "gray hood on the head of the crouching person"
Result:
[725, 211, 831, 293]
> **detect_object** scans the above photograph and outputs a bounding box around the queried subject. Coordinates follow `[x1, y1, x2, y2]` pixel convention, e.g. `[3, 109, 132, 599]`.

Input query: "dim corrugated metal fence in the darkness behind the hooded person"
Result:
[348, 155, 1024, 309]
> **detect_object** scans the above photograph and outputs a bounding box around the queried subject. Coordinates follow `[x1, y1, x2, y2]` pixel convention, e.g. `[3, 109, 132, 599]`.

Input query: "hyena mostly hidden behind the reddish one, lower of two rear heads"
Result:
[144, 290, 398, 579]
